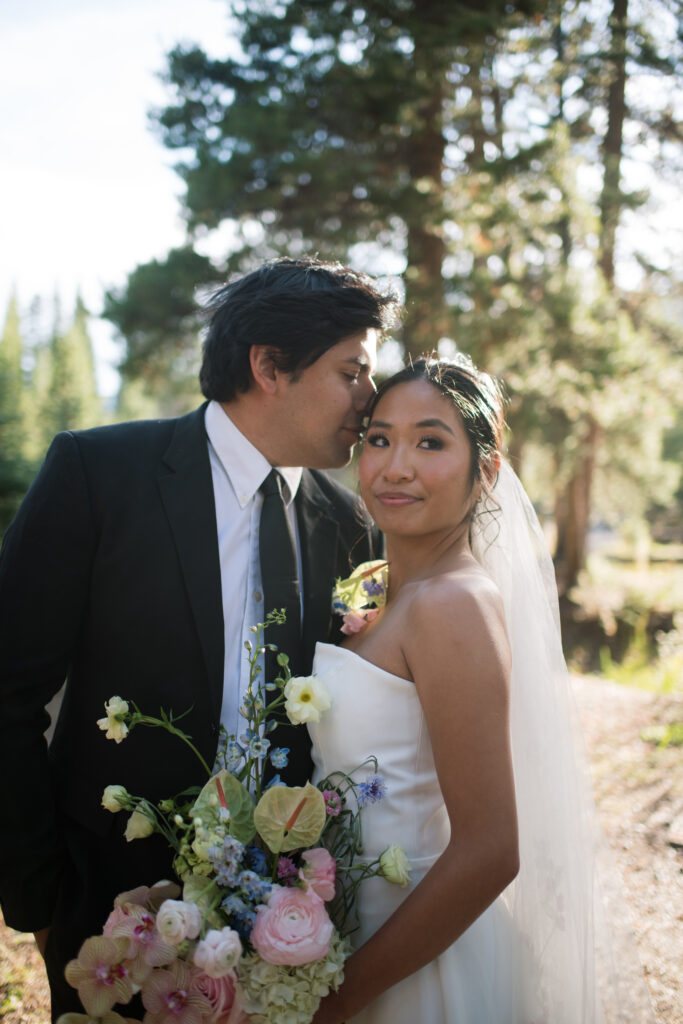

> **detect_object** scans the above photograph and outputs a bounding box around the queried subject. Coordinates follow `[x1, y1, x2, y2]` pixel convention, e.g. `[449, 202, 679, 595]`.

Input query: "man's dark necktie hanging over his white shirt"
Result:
[259, 469, 301, 682]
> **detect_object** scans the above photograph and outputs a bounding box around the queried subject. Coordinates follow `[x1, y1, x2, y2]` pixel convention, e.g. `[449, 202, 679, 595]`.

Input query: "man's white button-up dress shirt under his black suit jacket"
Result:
[205, 401, 303, 736]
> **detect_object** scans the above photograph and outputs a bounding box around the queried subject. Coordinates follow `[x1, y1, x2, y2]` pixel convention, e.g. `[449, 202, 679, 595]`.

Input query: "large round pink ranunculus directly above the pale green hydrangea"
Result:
[251, 886, 333, 966]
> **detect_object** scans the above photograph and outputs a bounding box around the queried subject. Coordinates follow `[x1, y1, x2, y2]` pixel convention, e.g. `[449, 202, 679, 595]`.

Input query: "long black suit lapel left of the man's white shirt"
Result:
[159, 406, 224, 720]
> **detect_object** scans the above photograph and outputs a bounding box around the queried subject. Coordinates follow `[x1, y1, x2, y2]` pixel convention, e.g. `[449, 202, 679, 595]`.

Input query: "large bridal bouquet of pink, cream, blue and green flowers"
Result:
[58, 611, 410, 1024]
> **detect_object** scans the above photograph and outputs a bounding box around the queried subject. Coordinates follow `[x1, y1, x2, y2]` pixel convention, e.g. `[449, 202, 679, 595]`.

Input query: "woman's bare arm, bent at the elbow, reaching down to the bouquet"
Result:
[314, 582, 518, 1024]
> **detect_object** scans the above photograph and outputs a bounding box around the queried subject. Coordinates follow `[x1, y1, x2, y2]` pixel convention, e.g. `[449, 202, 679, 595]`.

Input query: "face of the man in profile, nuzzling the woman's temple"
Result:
[278, 328, 377, 469]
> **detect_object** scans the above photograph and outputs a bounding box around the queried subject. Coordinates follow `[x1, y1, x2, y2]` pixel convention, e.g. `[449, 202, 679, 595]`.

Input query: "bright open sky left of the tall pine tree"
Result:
[0, 0, 228, 395]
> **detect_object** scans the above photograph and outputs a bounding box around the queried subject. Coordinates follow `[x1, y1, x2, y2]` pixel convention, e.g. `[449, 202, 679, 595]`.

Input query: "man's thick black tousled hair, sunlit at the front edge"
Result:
[200, 257, 399, 401]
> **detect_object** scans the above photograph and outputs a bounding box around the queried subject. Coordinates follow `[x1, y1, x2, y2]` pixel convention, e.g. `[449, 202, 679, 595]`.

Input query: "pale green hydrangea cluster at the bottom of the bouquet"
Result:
[238, 932, 350, 1024]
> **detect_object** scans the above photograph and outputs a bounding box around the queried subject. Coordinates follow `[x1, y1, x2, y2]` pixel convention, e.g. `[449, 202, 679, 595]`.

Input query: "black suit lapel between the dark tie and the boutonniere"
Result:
[296, 469, 339, 672]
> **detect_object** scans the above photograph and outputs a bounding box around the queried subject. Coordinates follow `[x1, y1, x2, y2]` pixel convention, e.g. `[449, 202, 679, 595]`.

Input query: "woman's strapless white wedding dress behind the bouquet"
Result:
[308, 643, 518, 1024]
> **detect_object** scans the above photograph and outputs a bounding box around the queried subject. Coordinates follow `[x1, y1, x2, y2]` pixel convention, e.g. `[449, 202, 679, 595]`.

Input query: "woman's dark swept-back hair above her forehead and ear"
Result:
[366, 355, 505, 496]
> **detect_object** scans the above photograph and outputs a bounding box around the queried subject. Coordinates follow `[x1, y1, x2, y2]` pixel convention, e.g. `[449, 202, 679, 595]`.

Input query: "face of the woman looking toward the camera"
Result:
[358, 381, 479, 537]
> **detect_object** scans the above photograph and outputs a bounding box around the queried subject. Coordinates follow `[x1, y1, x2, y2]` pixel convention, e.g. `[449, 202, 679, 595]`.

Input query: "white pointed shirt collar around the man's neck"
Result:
[204, 401, 303, 509]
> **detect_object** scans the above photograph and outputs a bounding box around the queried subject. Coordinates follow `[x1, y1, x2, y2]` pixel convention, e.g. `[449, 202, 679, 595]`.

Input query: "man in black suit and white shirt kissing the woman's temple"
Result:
[0, 253, 396, 1019]
